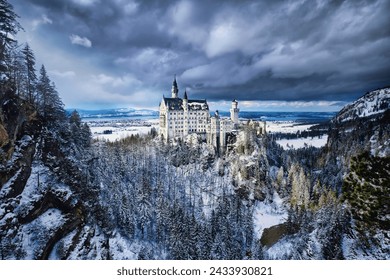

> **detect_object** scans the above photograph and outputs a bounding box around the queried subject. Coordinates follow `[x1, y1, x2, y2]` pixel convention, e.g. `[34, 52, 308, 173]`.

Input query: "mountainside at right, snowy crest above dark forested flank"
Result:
[321, 88, 390, 192]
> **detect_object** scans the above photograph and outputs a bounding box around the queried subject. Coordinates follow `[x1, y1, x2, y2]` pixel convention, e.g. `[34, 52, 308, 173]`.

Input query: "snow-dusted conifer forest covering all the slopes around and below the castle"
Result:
[0, 0, 390, 260]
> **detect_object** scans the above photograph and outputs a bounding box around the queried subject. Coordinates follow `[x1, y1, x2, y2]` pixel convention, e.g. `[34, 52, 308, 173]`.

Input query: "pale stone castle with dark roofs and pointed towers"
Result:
[160, 77, 240, 150]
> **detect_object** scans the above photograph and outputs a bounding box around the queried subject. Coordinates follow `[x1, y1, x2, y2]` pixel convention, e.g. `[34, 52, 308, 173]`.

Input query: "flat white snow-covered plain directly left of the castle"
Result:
[87, 119, 158, 142]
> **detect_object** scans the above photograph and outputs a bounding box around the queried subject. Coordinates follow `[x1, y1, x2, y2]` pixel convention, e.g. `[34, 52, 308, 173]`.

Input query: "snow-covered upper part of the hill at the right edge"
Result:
[334, 88, 390, 122]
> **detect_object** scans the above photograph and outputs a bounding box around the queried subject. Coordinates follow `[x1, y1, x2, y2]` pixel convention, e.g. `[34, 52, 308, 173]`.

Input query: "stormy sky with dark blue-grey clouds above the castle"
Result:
[9, 0, 390, 111]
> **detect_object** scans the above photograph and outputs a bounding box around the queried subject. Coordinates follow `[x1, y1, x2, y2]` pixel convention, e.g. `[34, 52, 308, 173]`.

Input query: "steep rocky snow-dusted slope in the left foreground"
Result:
[0, 90, 84, 259]
